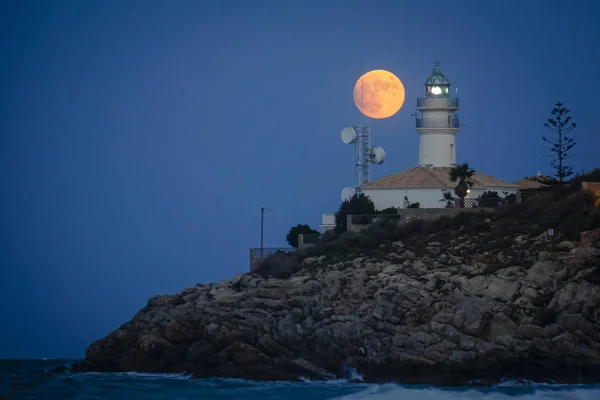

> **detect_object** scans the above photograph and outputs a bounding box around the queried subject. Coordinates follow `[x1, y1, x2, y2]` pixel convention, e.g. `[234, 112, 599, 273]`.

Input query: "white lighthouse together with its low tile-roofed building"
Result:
[321, 63, 518, 230]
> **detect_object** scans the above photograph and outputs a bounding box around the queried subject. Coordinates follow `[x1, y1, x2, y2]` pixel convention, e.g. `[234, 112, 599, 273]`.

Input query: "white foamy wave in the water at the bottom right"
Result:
[331, 384, 600, 400]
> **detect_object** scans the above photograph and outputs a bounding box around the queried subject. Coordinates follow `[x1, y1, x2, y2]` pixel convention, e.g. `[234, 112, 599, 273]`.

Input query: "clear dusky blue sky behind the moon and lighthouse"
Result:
[0, 0, 600, 358]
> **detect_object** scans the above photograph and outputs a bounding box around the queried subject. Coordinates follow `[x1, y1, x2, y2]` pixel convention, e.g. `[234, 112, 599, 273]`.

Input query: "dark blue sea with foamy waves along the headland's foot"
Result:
[0, 359, 600, 400]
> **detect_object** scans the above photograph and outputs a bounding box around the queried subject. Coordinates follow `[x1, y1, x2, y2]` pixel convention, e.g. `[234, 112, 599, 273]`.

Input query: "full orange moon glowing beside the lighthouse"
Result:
[354, 69, 404, 119]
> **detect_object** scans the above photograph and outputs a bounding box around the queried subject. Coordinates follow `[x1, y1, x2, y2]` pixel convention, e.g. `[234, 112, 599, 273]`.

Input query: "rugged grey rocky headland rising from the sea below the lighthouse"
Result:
[73, 191, 600, 385]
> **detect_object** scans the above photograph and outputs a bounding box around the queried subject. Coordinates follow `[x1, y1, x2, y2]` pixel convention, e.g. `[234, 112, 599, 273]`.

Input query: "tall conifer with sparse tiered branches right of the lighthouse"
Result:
[542, 103, 577, 182]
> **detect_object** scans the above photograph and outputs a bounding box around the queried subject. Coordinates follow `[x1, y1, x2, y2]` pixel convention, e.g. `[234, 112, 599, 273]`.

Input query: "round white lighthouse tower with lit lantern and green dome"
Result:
[416, 62, 459, 167]
